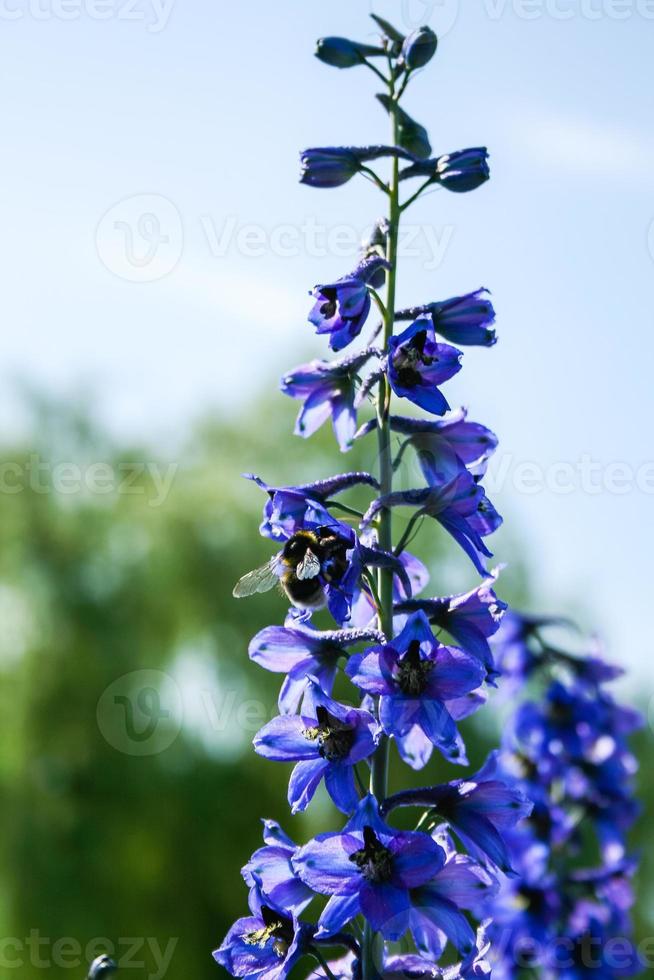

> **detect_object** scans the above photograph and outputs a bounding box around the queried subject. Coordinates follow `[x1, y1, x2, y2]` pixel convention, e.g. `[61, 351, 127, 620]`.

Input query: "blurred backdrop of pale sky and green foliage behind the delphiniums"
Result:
[0, 0, 654, 980]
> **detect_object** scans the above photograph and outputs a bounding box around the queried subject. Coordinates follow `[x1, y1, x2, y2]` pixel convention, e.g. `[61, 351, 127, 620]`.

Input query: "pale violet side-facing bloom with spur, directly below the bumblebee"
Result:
[249, 613, 384, 714]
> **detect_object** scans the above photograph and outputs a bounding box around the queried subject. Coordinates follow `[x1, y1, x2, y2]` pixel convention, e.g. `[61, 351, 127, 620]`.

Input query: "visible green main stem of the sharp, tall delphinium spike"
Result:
[361, 72, 401, 980]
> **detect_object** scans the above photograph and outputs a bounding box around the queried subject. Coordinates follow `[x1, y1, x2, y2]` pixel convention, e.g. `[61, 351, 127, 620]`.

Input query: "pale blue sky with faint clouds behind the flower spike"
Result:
[0, 0, 654, 691]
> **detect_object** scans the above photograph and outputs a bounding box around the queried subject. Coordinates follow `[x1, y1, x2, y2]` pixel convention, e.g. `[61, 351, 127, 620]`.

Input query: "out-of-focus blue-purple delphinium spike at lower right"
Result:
[488, 613, 641, 980]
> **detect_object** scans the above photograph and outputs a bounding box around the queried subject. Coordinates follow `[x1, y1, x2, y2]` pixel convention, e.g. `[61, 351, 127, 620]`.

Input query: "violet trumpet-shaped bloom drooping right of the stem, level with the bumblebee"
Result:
[362, 472, 502, 577]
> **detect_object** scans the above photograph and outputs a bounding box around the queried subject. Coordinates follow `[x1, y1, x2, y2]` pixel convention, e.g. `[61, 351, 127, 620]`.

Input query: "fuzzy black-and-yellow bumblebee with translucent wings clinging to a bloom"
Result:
[233, 527, 348, 609]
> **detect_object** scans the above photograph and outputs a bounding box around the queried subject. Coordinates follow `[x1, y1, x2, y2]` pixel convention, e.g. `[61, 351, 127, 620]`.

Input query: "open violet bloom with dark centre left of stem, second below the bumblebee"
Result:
[254, 684, 379, 813]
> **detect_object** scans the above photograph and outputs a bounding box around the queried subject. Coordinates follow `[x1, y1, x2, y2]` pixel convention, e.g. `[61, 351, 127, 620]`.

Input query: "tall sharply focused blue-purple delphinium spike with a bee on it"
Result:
[215, 15, 576, 980]
